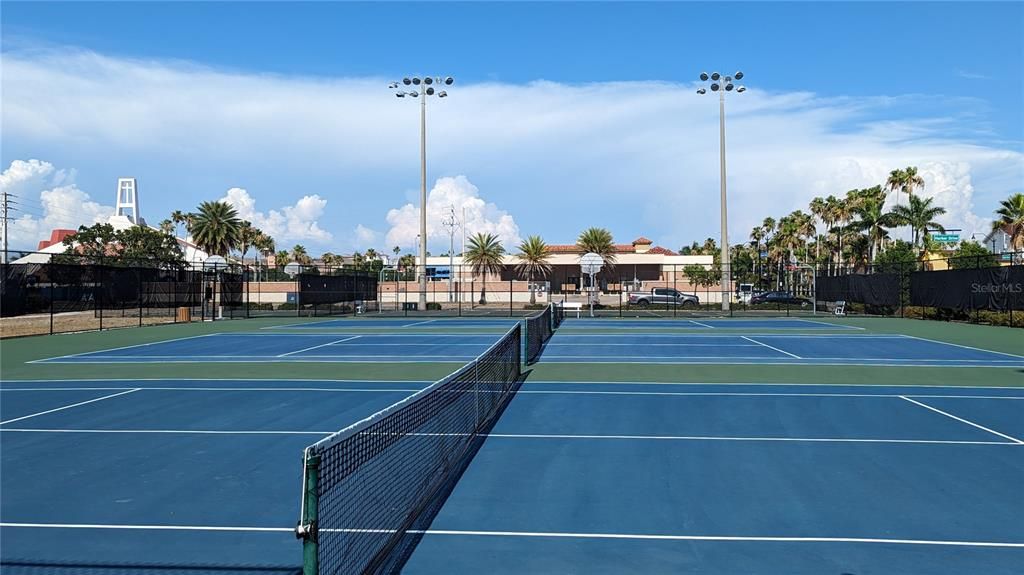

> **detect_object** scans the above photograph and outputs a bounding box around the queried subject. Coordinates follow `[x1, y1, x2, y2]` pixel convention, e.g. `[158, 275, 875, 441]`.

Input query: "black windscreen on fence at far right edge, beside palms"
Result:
[910, 266, 1024, 311]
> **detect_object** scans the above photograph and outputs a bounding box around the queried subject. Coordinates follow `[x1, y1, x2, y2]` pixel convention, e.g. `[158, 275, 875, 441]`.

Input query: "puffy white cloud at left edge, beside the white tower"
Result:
[0, 160, 114, 250]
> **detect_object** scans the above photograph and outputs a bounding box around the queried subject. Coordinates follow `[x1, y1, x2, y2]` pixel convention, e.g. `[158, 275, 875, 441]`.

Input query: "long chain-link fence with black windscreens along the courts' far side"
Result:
[0, 253, 1024, 337]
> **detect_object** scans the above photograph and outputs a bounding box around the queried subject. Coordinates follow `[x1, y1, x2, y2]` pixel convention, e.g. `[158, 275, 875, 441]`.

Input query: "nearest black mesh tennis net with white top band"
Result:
[296, 323, 522, 575]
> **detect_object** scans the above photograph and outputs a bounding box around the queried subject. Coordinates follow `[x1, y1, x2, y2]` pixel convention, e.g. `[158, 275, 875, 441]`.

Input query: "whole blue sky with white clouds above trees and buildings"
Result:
[0, 1, 1024, 254]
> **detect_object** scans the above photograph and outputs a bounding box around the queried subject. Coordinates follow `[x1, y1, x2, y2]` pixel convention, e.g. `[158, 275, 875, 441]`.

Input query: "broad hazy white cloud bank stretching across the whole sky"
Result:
[0, 44, 1024, 252]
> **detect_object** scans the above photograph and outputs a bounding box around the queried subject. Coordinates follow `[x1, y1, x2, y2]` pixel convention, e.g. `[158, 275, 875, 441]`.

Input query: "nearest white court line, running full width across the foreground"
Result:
[0, 522, 1024, 548]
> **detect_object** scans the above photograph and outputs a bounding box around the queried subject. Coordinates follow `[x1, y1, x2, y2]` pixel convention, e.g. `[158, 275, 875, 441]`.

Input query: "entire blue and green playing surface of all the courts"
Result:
[0, 311, 1024, 574]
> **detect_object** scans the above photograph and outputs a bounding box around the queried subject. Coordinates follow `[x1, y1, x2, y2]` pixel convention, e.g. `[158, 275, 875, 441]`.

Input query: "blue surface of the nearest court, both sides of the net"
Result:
[0, 378, 1024, 574]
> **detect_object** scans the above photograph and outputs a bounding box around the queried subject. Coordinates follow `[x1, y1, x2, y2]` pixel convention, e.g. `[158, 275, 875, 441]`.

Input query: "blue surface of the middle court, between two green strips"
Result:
[38, 331, 1024, 367]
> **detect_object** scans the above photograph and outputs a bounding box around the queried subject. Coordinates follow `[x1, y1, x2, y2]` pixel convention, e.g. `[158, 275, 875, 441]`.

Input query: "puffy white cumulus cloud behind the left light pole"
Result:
[386, 176, 519, 252]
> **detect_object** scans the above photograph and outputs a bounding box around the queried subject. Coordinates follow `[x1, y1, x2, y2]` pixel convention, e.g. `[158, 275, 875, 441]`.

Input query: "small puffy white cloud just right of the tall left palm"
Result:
[220, 187, 332, 245]
